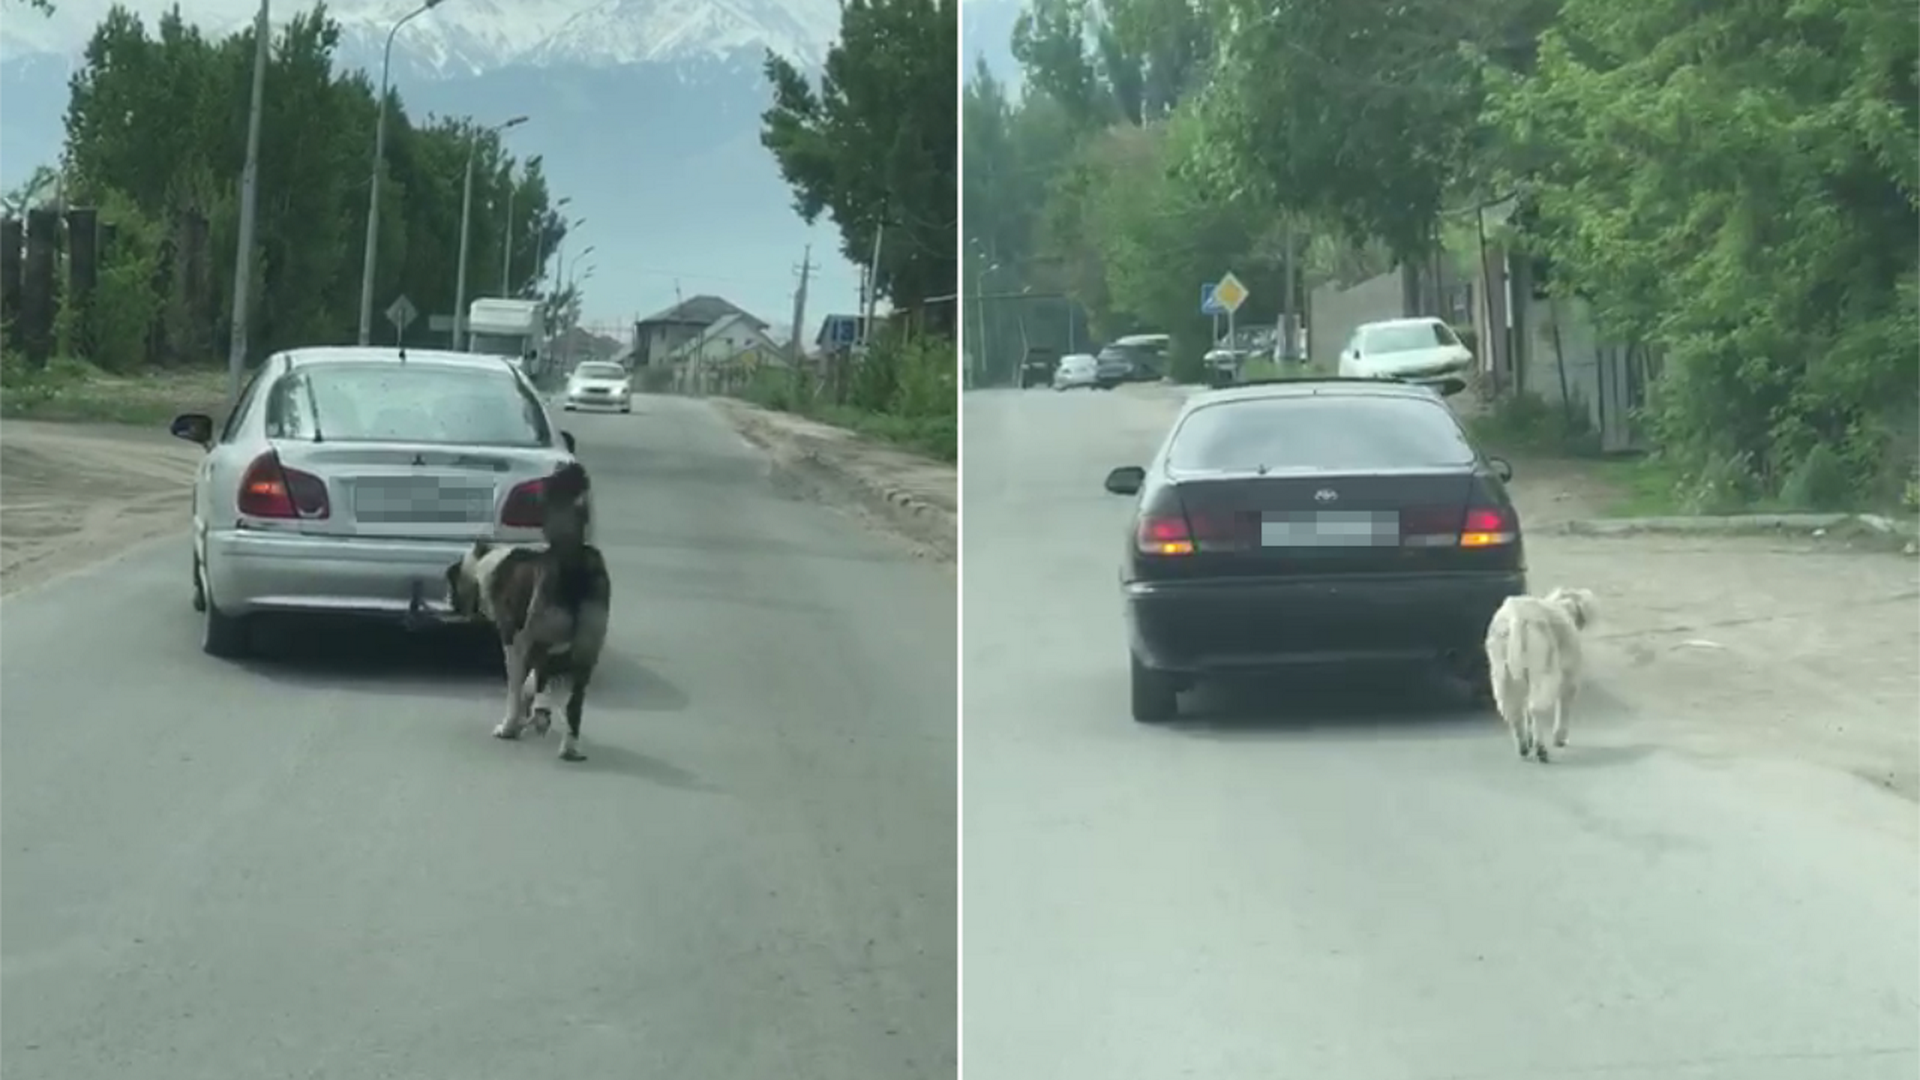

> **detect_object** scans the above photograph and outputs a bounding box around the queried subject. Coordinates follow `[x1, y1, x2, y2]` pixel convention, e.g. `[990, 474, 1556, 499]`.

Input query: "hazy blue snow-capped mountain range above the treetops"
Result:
[0, 0, 856, 336]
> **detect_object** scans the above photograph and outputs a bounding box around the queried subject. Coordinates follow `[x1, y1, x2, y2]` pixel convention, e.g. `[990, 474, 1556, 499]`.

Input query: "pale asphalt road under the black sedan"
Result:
[962, 390, 1920, 1080]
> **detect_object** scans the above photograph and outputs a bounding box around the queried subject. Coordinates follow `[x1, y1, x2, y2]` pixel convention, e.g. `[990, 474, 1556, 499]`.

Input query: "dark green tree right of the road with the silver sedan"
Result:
[760, 0, 958, 307]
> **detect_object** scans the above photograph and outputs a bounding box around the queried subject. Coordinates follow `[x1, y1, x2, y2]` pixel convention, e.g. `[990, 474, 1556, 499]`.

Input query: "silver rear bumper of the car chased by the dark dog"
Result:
[204, 530, 483, 623]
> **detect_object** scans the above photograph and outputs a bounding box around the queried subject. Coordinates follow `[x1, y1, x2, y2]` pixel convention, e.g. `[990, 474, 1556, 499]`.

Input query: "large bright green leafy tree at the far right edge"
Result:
[1488, 0, 1920, 498]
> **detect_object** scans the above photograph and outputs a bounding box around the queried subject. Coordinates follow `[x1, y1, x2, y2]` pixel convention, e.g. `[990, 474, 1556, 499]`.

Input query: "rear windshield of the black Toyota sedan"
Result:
[1167, 388, 1475, 473]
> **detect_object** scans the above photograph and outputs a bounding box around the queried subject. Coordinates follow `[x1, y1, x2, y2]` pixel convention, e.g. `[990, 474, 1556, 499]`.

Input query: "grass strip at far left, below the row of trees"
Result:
[0, 357, 227, 425]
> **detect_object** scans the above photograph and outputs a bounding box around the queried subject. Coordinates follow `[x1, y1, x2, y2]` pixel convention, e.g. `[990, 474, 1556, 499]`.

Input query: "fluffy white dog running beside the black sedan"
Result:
[1486, 588, 1599, 763]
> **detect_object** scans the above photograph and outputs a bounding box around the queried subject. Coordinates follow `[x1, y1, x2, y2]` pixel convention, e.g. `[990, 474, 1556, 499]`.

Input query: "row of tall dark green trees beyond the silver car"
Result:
[54, 6, 561, 363]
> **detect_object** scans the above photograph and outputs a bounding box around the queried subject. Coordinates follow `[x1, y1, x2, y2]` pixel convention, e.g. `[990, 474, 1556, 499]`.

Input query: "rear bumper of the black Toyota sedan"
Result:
[1123, 571, 1526, 675]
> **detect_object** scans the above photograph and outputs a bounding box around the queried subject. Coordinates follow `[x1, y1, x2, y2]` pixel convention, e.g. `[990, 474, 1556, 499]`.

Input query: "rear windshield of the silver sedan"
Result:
[267, 361, 553, 446]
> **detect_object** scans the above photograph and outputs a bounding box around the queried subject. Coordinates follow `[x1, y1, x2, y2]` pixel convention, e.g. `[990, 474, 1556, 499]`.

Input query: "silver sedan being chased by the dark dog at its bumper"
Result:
[173, 348, 574, 657]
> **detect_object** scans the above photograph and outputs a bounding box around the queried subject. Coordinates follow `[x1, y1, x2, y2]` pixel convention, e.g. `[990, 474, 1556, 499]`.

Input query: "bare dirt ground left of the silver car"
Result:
[0, 419, 202, 594]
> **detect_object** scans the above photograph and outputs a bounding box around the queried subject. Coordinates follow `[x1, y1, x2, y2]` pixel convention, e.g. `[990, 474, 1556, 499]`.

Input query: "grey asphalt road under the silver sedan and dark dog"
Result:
[0, 398, 956, 1080]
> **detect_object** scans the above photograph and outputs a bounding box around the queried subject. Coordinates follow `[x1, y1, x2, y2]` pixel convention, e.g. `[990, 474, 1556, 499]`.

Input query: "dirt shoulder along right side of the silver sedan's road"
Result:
[712, 398, 960, 561]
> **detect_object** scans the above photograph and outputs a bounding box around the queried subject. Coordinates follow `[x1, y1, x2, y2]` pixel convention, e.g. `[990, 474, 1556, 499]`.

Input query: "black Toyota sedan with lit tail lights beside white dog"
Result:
[1106, 379, 1526, 723]
